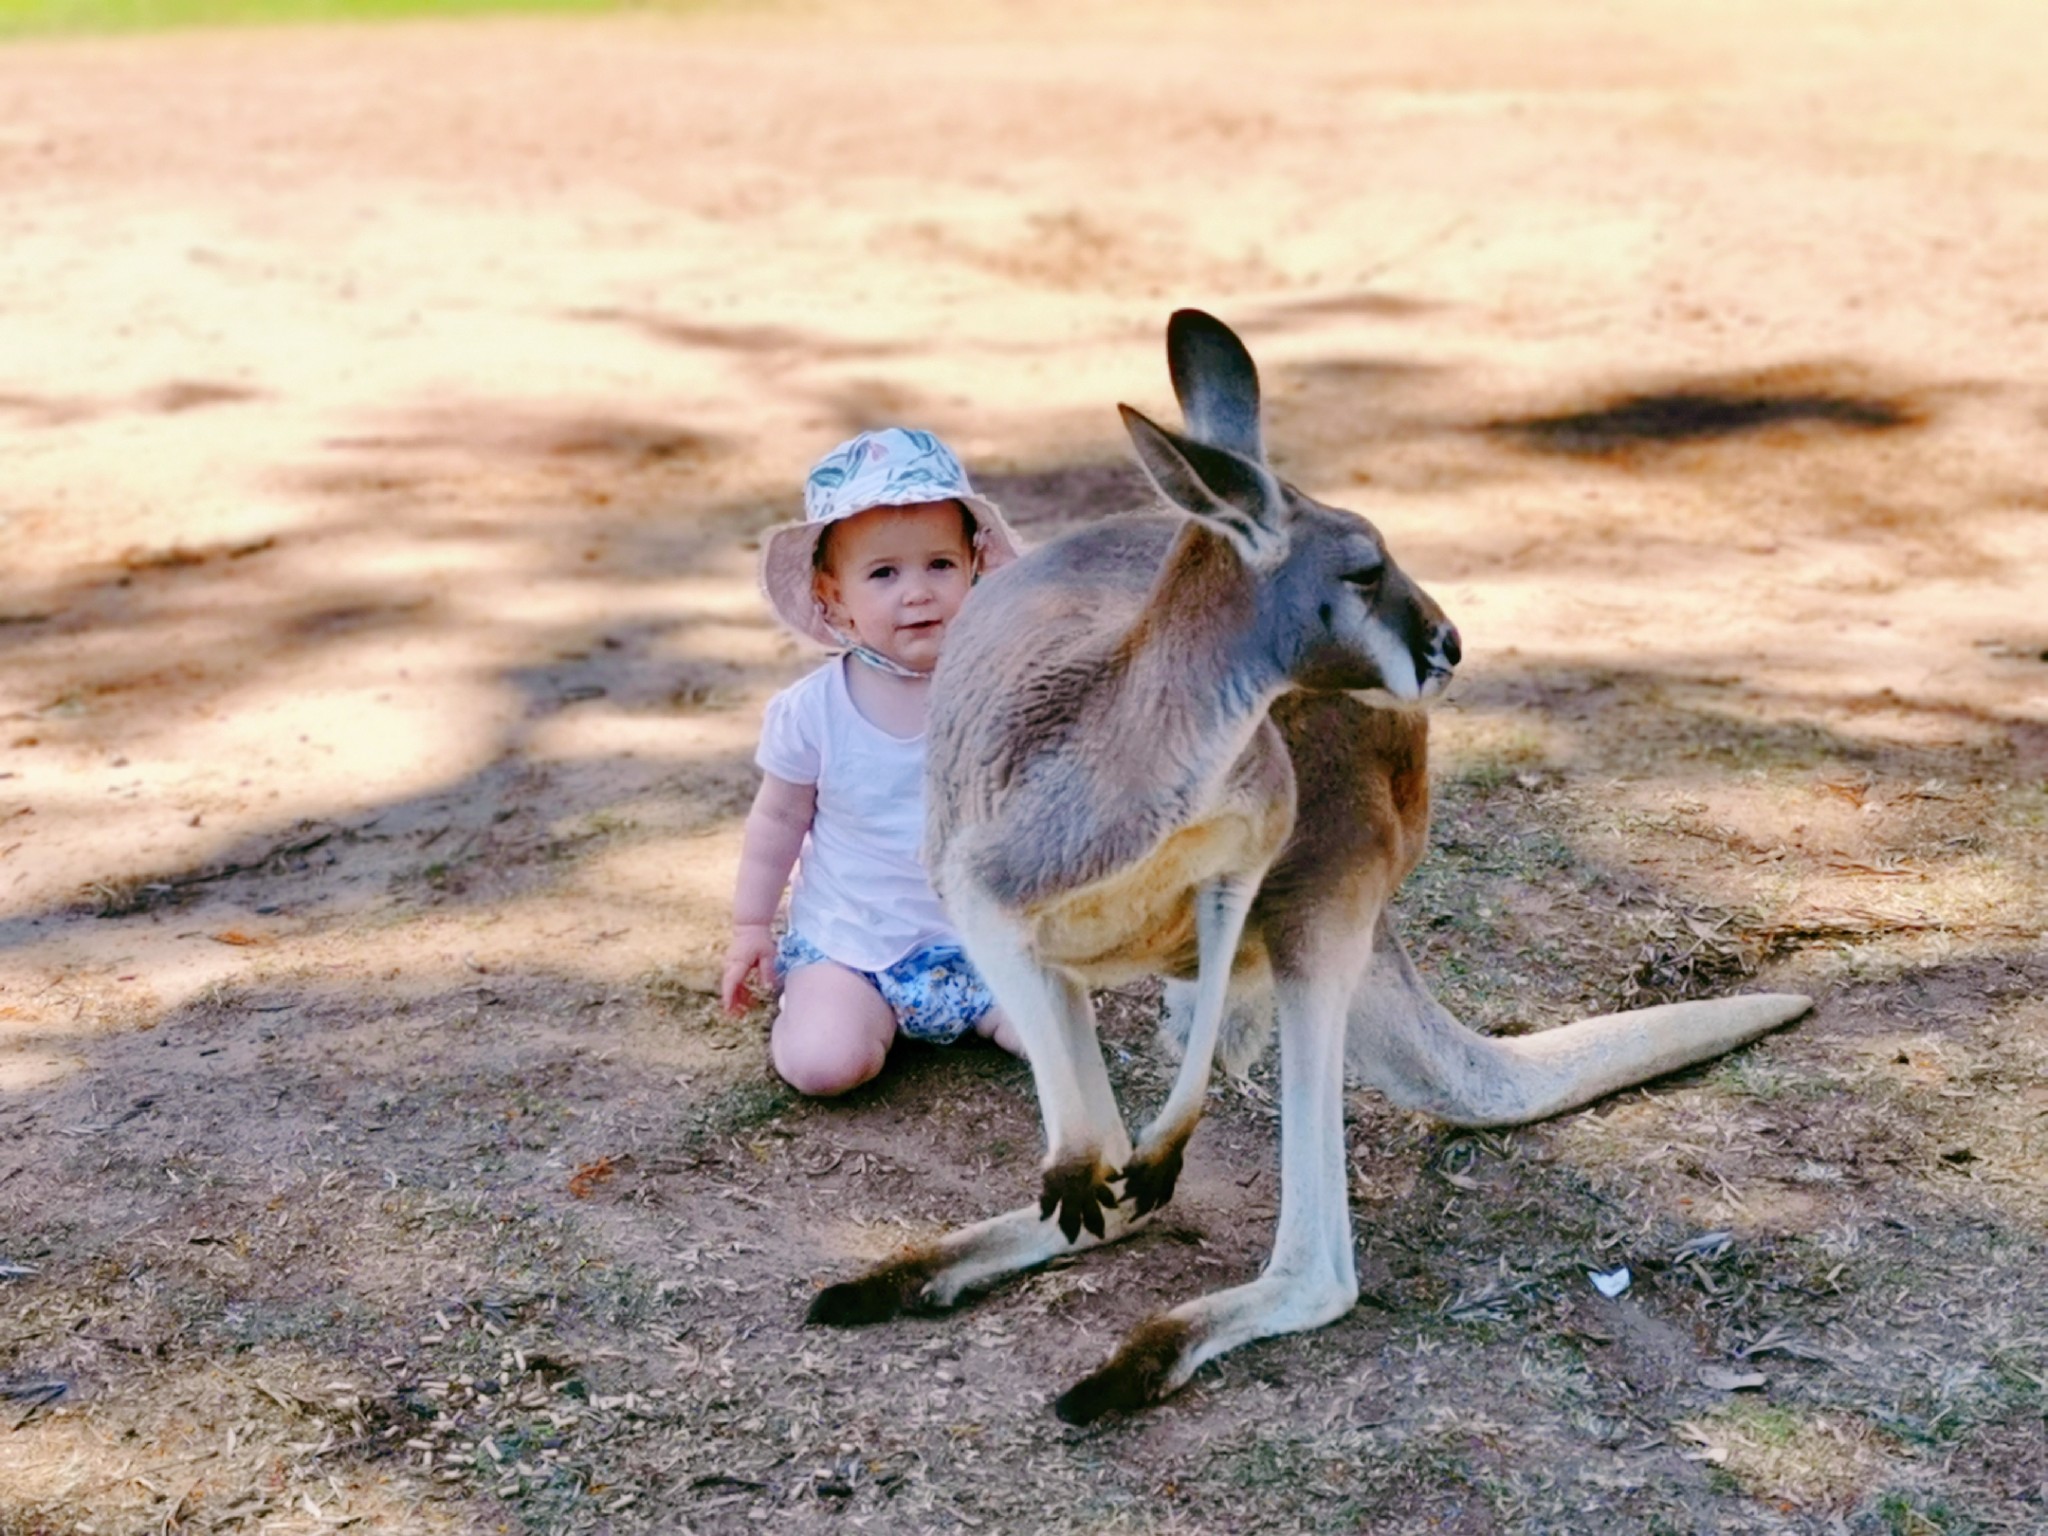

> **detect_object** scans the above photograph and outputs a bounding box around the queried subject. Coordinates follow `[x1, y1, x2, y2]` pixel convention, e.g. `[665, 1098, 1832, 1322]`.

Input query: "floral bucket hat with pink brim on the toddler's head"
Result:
[762, 426, 1018, 651]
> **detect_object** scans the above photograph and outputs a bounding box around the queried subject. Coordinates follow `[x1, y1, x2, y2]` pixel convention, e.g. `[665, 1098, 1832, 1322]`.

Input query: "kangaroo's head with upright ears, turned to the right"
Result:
[1120, 309, 1458, 705]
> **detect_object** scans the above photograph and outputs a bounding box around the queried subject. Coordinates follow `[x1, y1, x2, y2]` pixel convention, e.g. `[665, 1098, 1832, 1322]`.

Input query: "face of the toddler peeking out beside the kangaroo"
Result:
[817, 502, 975, 672]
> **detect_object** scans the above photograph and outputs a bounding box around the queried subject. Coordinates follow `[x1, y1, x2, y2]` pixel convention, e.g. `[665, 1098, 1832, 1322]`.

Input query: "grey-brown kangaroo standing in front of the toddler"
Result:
[809, 309, 1810, 1423]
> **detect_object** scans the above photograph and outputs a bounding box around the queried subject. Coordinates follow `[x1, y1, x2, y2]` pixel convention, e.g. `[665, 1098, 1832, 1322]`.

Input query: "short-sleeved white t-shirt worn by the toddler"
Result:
[754, 655, 961, 971]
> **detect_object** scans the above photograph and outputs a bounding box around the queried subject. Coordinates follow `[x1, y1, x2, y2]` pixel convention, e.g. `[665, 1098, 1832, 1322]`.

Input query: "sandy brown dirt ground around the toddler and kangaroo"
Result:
[0, 0, 2048, 1536]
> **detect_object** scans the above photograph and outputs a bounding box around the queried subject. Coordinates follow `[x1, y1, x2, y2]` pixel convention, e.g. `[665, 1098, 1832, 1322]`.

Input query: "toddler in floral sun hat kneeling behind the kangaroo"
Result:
[719, 428, 1018, 1096]
